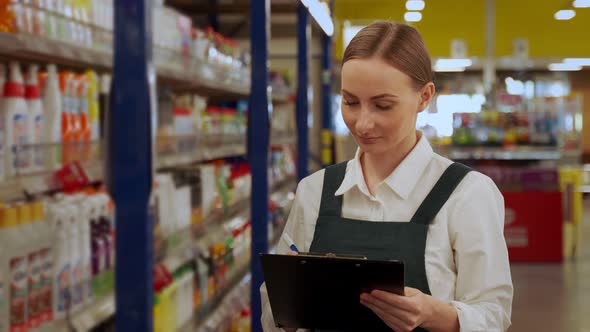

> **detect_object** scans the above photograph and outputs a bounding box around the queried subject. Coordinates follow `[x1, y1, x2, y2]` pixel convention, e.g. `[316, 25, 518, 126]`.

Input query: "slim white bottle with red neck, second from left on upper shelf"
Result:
[25, 65, 44, 171]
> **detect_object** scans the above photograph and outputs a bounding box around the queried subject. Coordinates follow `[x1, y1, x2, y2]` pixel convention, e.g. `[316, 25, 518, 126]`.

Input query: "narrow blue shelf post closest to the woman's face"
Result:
[322, 0, 334, 167]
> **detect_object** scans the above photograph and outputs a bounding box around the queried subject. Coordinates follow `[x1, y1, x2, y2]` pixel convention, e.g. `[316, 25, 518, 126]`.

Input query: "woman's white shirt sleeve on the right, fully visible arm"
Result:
[449, 172, 513, 332]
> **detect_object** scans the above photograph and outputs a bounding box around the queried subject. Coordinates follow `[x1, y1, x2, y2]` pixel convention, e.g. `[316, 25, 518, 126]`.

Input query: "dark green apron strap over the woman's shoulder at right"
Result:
[410, 163, 472, 225]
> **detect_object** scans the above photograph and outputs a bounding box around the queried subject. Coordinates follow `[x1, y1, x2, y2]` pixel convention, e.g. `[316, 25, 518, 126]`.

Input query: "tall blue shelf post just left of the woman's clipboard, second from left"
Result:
[248, 0, 271, 332]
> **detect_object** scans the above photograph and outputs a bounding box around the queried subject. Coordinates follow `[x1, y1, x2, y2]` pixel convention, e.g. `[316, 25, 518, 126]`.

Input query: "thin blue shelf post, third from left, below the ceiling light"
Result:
[295, 1, 311, 181]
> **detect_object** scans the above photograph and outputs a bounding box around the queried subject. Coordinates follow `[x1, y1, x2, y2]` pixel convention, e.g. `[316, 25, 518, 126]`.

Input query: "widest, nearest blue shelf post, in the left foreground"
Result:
[107, 0, 153, 332]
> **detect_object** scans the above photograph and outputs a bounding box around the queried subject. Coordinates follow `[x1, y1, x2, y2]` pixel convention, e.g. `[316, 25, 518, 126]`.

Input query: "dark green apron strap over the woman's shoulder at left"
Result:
[319, 162, 348, 217]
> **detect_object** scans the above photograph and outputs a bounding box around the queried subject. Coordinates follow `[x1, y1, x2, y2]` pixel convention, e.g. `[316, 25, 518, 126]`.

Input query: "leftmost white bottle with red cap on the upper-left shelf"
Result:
[2, 62, 29, 176]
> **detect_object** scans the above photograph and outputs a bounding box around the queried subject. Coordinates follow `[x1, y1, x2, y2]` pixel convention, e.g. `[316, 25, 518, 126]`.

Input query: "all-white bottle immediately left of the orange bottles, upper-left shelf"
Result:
[43, 65, 63, 169]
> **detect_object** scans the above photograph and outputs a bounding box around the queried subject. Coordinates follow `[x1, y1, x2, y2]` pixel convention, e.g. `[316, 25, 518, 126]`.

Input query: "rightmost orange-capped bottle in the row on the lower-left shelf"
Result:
[33, 201, 53, 326]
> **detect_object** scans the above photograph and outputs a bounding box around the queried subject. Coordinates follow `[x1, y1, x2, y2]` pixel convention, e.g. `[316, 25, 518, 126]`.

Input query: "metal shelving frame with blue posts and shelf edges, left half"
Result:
[0, 0, 328, 331]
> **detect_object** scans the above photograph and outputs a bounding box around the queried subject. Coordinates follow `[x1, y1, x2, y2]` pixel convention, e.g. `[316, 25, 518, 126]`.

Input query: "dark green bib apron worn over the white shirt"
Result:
[309, 163, 471, 331]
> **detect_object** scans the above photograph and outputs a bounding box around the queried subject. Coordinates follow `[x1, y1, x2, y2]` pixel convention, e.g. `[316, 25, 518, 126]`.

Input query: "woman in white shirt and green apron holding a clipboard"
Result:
[262, 22, 513, 332]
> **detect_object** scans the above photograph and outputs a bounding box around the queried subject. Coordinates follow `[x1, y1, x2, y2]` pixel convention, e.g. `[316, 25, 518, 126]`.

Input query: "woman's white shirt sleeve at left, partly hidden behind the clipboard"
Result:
[260, 182, 305, 332]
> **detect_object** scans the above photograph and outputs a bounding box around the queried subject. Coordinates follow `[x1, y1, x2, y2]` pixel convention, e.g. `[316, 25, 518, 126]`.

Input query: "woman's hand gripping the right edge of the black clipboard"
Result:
[361, 287, 434, 332]
